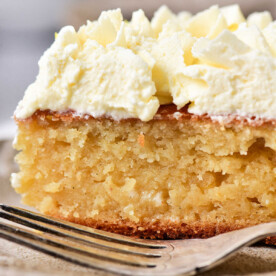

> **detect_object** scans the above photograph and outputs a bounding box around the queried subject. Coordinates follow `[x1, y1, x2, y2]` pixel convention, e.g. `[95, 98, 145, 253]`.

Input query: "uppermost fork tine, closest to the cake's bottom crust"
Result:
[0, 204, 166, 249]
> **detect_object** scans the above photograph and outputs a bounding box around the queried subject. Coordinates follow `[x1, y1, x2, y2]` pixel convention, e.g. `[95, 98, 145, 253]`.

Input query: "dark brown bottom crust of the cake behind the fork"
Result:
[48, 214, 276, 246]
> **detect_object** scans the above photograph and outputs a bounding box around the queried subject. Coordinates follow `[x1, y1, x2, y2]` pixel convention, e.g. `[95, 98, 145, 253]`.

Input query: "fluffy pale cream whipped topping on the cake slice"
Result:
[15, 5, 276, 121]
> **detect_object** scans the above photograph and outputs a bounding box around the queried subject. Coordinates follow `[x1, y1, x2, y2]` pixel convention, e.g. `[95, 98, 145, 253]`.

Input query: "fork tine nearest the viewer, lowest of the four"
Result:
[0, 223, 160, 275]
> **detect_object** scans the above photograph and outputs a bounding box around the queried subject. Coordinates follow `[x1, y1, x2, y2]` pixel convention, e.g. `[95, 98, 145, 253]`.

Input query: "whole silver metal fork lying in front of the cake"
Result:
[0, 205, 276, 275]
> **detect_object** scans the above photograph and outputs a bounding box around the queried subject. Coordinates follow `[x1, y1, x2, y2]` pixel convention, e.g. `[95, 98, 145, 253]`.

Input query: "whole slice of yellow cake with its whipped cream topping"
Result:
[11, 5, 276, 244]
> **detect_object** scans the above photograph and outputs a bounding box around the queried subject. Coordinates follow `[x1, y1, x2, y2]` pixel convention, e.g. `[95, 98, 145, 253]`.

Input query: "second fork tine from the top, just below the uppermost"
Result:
[0, 211, 165, 258]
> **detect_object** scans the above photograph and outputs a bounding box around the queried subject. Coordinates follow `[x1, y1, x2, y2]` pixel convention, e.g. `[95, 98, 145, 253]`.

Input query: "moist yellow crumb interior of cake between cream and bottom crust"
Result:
[12, 113, 276, 240]
